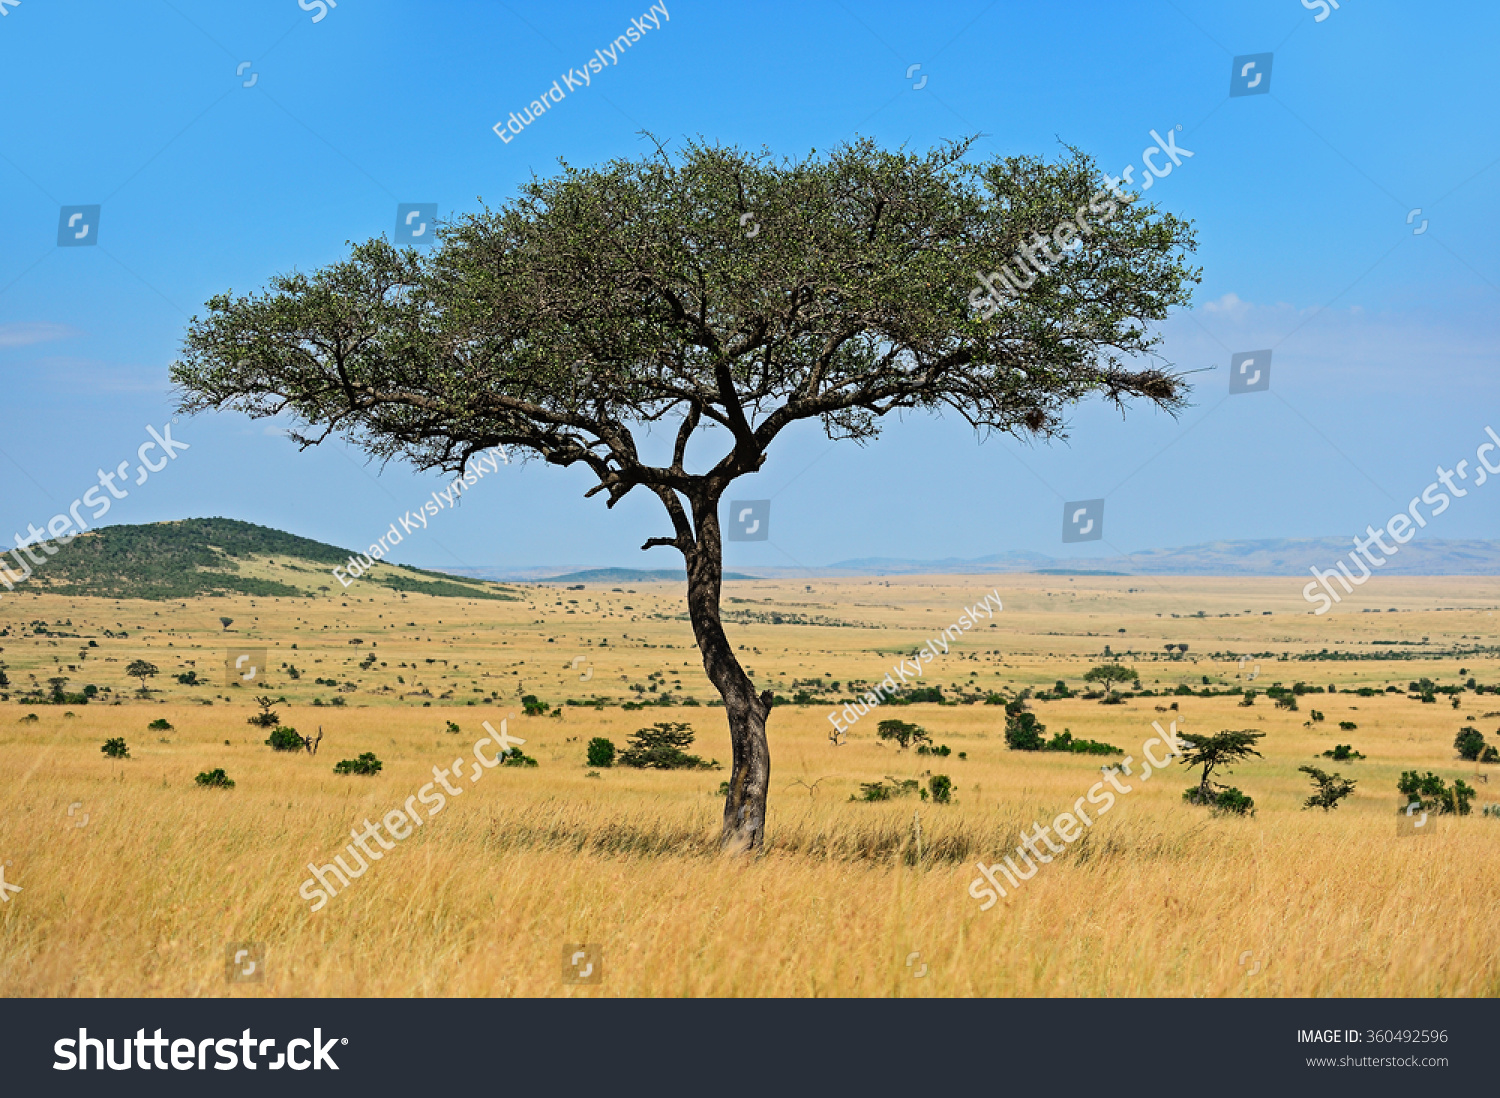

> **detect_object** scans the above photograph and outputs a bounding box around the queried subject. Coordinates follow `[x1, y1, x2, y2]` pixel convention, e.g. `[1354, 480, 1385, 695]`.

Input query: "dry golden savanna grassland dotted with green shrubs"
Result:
[0, 564, 1500, 996]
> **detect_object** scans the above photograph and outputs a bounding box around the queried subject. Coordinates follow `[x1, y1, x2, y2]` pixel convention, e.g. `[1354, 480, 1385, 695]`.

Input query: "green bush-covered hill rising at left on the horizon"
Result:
[7, 519, 516, 600]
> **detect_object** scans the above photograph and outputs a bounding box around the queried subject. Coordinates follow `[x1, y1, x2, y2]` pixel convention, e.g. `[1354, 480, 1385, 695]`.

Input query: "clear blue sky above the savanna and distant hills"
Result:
[0, 0, 1500, 567]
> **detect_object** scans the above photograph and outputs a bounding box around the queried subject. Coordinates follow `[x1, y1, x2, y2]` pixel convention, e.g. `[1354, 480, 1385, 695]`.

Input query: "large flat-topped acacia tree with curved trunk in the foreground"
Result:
[173, 140, 1197, 851]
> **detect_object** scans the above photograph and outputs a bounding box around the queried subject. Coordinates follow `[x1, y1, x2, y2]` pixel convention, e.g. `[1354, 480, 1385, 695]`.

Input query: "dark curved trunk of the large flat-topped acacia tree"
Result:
[684, 500, 771, 854]
